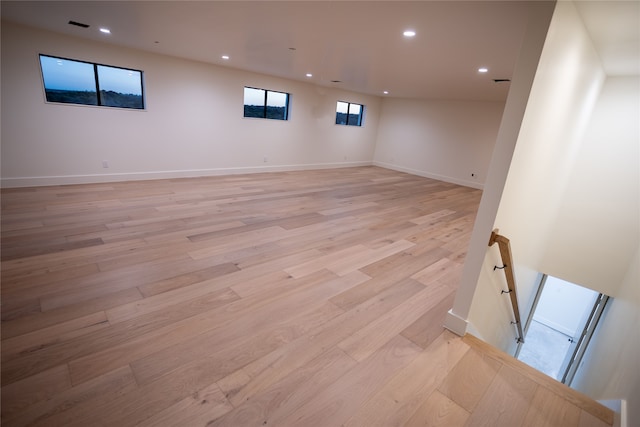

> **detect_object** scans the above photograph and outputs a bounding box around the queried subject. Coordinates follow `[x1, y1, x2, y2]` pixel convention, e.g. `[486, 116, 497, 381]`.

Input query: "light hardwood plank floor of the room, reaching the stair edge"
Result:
[1, 167, 611, 427]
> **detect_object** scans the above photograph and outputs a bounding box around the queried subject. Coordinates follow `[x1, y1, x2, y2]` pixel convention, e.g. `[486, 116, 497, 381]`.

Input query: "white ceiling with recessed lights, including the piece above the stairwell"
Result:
[1, 0, 640, 101]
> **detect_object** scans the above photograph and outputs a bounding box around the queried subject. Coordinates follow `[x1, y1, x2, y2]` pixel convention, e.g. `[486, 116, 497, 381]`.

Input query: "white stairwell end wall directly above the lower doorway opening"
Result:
[540, 76, 640, 296]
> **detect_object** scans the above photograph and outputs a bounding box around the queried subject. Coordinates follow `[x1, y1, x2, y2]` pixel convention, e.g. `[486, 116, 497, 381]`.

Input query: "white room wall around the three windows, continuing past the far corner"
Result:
[2, 22, 504, 188]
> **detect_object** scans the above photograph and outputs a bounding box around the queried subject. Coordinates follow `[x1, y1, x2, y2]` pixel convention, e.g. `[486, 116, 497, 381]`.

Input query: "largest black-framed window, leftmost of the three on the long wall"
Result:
[40, 55, 144, 110]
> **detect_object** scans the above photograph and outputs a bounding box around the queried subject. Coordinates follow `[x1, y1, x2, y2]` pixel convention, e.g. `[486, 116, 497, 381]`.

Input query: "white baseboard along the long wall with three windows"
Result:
[1, 162, 372, 188]
